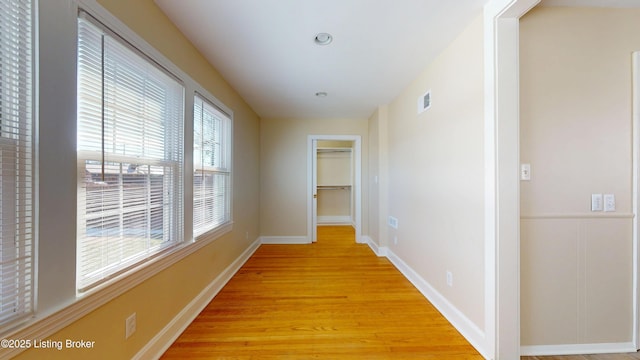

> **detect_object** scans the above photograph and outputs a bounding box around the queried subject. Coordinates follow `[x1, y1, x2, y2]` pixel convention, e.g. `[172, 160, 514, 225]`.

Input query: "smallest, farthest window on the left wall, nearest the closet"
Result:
[193, 95, 231, 236]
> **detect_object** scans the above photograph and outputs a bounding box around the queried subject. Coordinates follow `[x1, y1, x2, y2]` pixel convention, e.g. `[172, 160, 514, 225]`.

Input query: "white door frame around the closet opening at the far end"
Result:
[307, 135, 362, 243]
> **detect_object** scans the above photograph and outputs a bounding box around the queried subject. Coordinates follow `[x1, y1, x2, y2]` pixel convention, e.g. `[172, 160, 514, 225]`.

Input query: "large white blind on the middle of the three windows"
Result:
[77, 13, 184, 291]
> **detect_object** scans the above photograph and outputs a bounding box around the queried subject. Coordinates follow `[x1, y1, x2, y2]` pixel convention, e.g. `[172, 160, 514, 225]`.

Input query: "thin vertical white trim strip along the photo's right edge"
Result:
[632, 51, 640, 349]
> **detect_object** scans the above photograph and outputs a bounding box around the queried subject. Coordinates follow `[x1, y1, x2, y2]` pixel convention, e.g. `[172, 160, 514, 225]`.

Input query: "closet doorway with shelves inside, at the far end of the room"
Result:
[307, 135, 362, 242]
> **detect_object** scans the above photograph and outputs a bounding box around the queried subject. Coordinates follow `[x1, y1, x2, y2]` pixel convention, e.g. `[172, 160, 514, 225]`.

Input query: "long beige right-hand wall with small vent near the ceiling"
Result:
[382, 16, 484, 329]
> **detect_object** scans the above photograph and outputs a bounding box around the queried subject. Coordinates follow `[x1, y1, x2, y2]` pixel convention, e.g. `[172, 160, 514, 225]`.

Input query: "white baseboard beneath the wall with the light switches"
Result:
[520, 342, 637, 356]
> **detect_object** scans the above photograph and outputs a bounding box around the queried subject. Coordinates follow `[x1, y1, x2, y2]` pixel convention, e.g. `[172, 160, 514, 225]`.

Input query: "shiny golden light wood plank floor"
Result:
[162, 227, 482, 360]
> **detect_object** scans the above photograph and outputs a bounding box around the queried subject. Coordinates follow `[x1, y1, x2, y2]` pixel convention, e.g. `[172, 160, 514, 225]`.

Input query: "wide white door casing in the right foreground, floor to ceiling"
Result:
[484, 0, 540, 360]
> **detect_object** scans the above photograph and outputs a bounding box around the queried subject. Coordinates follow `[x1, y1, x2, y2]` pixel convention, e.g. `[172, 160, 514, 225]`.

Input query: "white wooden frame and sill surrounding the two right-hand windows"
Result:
[0, 0, 235, 350]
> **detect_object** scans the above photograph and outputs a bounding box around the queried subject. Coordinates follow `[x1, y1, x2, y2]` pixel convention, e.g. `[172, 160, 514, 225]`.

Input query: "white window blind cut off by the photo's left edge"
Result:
[0, 0, 34, 324]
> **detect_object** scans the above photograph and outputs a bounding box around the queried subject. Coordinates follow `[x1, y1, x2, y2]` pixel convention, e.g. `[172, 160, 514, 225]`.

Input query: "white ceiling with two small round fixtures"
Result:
[155, 0, 640, 119]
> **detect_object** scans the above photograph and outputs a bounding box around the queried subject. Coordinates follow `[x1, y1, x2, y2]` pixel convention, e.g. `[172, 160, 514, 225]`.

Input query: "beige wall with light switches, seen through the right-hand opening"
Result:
[520, 7, 640, 346]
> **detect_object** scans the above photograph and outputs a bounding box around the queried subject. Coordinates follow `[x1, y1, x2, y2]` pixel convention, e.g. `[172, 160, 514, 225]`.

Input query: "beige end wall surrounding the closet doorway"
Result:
[260, 119, 368, 237]
